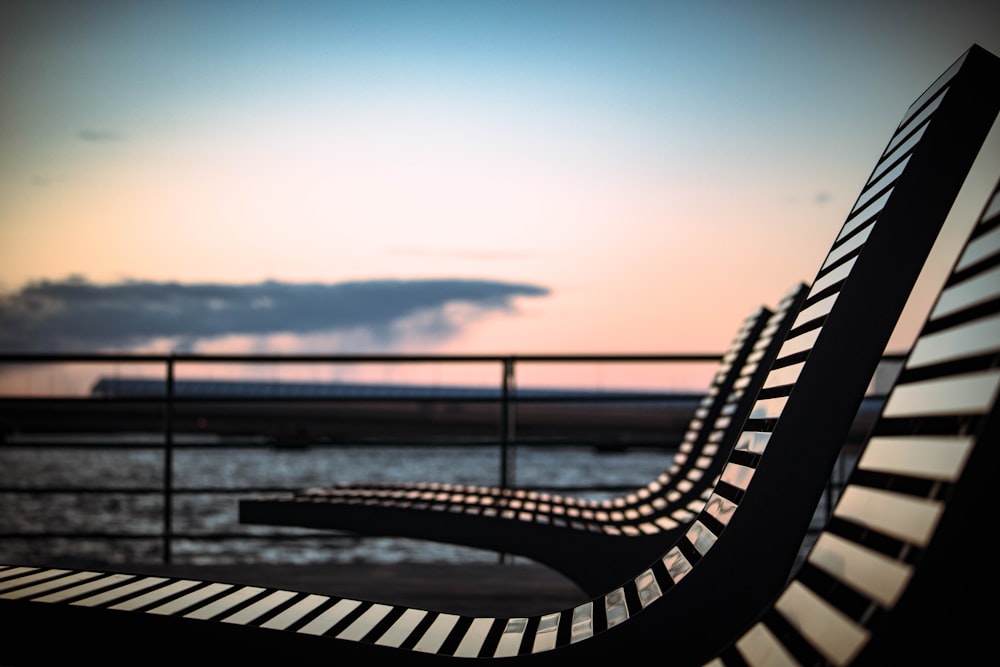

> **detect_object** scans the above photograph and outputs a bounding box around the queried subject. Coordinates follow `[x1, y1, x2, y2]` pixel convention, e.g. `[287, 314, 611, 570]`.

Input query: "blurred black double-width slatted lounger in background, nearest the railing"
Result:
[240, 284, 807, 595]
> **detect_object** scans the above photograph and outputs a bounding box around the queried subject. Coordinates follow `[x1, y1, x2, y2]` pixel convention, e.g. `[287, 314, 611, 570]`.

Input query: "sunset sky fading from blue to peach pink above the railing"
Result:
[0, 0, 1000, 392]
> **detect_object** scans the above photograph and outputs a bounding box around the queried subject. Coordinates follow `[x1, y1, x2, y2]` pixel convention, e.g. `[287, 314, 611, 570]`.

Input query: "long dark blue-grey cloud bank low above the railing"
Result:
[0, 277, 548, 352]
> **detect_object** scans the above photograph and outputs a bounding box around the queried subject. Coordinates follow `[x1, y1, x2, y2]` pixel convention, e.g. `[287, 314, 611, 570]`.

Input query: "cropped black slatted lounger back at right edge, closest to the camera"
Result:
[711, 174, 1000, 667]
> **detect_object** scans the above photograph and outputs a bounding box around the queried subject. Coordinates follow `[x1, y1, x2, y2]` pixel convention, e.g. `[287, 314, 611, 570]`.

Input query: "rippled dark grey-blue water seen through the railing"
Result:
[0, 445, 671, 564]
